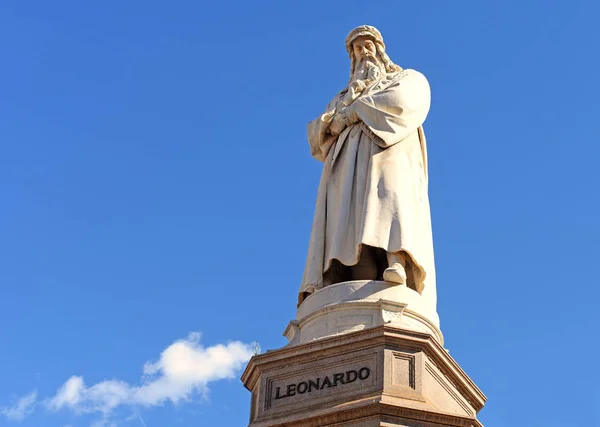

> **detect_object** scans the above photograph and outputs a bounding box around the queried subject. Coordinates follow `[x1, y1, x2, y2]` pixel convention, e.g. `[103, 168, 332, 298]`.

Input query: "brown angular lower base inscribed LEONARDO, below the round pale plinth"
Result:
[242, 324, 485, 427]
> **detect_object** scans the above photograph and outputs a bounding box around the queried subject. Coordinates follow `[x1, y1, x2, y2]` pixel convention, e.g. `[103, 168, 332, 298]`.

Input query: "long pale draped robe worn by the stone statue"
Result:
[299, 70, 435, 310]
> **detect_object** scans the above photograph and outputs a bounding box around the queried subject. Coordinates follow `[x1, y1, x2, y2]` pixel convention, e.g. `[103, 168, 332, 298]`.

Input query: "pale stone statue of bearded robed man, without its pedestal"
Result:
[299, 25, 435, 310]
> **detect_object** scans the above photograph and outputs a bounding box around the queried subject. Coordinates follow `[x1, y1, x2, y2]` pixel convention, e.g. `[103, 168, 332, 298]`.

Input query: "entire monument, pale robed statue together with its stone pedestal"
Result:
[242, 25, 486, 427]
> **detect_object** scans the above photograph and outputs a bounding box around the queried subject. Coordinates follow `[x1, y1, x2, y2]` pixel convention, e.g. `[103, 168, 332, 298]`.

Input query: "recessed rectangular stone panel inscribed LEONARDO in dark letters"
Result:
[260, 353, 377, 414]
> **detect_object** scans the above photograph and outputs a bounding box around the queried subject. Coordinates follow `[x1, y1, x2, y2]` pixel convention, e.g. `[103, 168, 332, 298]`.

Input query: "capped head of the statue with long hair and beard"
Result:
[346, 25, 402, 81]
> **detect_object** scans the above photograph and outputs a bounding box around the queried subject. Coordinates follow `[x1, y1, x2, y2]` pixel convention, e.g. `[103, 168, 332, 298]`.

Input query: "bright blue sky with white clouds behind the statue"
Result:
[0, 0, 600, 427]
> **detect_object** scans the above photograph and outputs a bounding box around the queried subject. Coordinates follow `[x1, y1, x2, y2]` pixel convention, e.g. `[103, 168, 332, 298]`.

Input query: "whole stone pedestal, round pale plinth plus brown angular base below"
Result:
[242, 282, 485, 427]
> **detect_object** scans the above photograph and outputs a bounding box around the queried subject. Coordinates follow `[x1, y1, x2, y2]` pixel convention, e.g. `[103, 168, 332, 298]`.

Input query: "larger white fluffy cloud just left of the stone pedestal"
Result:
[45, 333, 252, 416]
